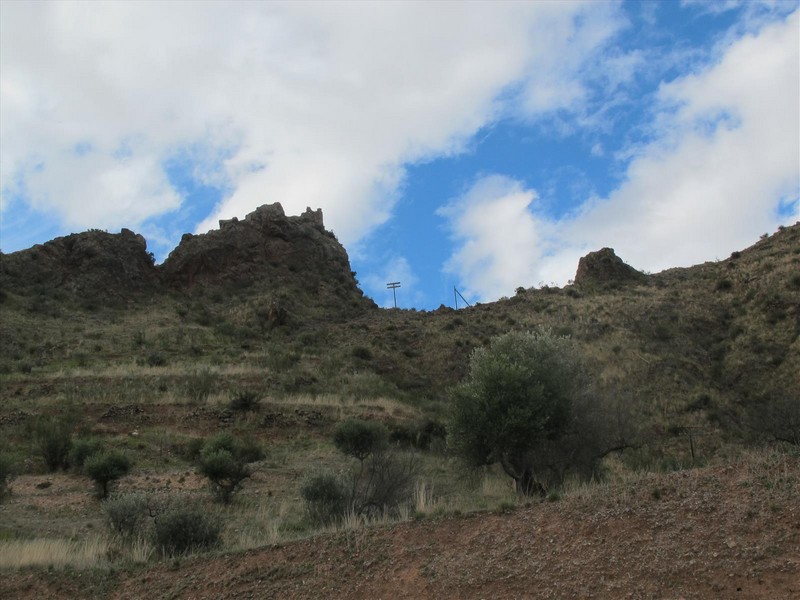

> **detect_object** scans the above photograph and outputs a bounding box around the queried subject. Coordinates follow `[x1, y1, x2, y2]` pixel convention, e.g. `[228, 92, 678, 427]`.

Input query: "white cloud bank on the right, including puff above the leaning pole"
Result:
[442, 12, 800, 299]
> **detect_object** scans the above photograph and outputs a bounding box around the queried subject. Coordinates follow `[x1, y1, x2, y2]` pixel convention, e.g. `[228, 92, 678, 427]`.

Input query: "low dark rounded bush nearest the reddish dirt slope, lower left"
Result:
[154, 507, 222, 556]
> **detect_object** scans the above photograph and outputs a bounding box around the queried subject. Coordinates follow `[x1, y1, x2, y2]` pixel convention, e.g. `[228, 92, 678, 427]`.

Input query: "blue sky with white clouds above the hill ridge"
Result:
[0, 0, 800, 310]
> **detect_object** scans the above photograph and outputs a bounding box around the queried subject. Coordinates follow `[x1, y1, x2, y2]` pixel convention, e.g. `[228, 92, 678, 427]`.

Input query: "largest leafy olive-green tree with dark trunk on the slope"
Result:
[448, 330, 585, 495]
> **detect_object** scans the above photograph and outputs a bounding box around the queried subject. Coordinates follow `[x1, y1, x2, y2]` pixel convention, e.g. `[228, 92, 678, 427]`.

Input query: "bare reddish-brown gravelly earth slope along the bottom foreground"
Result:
[0, 452, 800, 600]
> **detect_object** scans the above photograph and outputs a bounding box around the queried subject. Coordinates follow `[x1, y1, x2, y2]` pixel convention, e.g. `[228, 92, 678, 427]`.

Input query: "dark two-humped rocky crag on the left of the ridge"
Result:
[0, 203, 374, 318]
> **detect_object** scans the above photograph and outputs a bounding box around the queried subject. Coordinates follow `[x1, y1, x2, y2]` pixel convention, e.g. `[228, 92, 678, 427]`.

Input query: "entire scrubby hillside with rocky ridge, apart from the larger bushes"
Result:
[0, 209, 800, 599]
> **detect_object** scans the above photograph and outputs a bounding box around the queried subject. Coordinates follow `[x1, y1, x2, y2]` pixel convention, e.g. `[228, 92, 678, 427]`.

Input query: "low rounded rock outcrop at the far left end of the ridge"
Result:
[0, 229, 160, 303]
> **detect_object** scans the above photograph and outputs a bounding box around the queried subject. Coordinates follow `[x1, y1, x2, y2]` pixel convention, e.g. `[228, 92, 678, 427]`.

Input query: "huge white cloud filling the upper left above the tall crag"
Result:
[0, 2, 619, 243]
